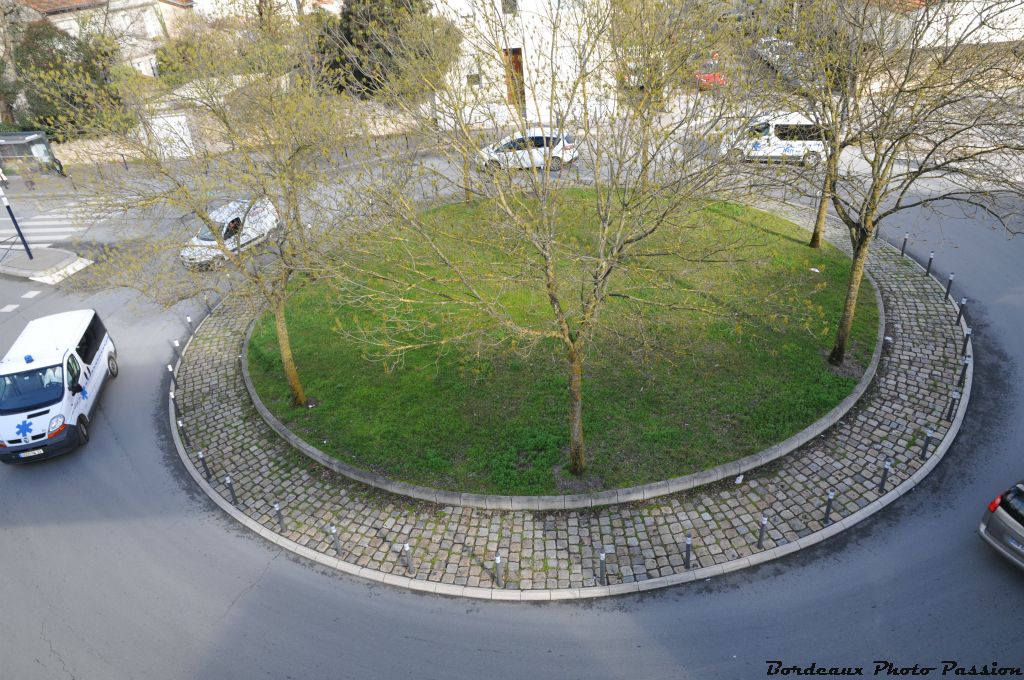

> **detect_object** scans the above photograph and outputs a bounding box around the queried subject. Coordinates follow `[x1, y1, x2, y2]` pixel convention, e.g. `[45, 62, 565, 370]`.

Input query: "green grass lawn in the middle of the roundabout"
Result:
[249, 190, 878, 495]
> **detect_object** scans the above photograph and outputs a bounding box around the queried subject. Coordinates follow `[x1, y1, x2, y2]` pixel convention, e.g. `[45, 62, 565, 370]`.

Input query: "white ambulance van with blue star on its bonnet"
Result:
[0, 309, 118, 463]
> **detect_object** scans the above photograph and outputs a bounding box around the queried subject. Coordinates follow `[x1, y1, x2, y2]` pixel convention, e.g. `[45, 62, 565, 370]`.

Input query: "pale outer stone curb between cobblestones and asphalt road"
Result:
[168, 204, 974, 601]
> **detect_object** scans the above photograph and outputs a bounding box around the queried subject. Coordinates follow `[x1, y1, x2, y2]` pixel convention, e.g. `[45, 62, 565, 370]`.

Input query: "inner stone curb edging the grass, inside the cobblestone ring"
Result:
[242, 255, 886, 511]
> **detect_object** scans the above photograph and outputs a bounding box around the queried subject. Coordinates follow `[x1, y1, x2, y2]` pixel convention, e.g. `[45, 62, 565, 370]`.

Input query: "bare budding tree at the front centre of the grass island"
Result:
[326, 0, 757, 474]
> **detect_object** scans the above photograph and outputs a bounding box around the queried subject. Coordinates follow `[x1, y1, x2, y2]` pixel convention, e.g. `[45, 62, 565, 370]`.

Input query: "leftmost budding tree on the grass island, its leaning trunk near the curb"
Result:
[40, 5, 364, 405]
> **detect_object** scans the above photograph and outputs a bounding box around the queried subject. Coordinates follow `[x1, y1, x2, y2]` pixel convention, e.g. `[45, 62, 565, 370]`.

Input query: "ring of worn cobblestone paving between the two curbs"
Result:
[177, 206, 964, 590]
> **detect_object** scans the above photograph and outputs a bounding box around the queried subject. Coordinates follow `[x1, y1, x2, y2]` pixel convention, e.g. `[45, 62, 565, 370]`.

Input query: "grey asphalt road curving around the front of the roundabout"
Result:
[0, 186, 1024, 680]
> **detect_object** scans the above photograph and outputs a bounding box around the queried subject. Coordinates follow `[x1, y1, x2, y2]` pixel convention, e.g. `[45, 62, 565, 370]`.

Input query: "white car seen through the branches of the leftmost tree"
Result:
[181, 199, 281, 268]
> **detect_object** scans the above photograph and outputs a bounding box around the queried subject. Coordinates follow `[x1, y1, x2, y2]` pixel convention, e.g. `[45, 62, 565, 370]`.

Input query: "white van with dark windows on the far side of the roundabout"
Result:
[727, 114, 825, 166]
